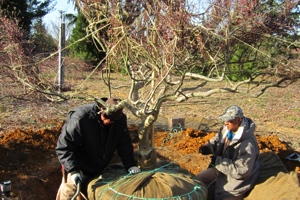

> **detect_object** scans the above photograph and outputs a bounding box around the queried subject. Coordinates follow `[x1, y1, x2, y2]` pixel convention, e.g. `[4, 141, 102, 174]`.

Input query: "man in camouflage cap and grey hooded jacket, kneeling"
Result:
[197, 105, 260, 200]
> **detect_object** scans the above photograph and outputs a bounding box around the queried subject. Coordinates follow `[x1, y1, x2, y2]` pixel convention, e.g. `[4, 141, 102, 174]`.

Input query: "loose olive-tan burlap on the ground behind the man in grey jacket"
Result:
[244, 152, 300, 200]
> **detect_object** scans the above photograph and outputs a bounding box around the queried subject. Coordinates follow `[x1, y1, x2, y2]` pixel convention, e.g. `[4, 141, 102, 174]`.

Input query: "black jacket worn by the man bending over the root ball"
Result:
[55, 101, 136, 176]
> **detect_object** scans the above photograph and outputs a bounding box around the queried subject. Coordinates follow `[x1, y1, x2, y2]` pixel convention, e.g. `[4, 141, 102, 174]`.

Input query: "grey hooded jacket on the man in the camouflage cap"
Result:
[206, 117, 260, 199]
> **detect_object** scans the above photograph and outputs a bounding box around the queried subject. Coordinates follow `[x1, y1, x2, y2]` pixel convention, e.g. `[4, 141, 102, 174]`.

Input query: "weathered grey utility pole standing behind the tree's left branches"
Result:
[58, 10, 66, 92]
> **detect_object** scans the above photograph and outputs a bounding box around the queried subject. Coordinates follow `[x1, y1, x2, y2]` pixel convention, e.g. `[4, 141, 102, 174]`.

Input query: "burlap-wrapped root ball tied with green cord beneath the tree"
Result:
[88, 171, 207, 200]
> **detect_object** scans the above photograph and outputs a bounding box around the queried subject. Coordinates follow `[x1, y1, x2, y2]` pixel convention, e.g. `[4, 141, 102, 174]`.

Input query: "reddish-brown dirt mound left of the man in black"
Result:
[0, 124, 62, 200]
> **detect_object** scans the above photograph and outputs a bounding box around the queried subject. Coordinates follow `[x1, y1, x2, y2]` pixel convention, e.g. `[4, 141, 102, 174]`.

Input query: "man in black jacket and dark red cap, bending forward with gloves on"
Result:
[55, 98, 140, 200]
